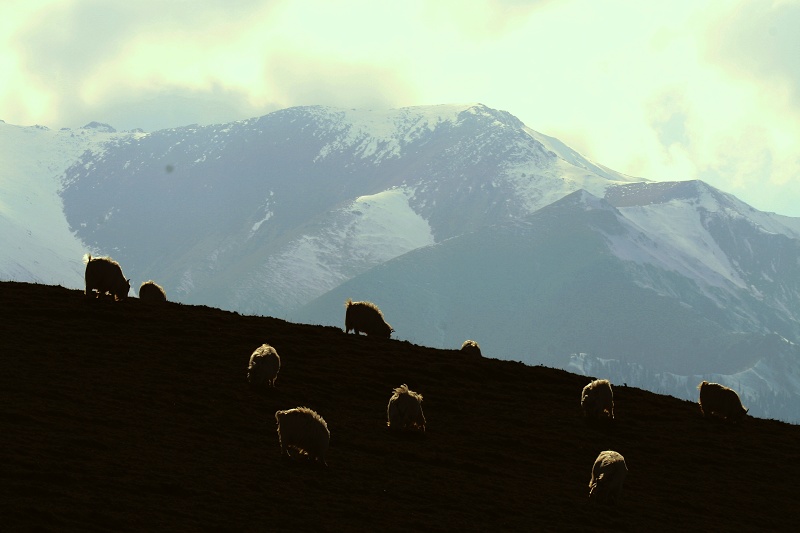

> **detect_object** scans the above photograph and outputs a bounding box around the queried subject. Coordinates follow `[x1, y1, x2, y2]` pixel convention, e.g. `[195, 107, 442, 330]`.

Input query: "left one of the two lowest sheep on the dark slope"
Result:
[275, 407, 331, 466]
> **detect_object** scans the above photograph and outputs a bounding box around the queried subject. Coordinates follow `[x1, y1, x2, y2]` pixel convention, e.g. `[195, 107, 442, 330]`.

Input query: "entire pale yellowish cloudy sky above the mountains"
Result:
[0, 0, 800, 216]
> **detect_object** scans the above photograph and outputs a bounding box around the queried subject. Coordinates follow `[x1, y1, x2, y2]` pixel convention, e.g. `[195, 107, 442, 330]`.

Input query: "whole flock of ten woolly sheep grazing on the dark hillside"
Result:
[84, 255, 747, 503]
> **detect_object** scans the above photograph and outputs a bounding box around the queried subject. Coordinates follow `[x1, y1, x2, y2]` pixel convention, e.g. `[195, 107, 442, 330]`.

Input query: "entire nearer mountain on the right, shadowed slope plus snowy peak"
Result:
[290, 187, 800, 420]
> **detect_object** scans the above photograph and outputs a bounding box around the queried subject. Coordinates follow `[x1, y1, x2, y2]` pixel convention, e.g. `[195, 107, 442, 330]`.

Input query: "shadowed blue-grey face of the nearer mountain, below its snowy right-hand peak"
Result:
[296, 191, 800, 420]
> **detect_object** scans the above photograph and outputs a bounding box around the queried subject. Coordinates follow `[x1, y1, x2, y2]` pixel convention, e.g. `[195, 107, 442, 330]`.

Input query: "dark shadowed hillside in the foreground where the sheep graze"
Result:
[0, 282, 800, 531]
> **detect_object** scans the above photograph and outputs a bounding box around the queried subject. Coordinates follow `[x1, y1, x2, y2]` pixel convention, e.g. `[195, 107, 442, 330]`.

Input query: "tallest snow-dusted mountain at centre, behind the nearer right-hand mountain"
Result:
[56, 105, 635, 315]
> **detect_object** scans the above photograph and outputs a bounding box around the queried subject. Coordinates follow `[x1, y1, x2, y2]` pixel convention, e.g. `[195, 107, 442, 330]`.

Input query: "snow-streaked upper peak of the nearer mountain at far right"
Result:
[606, 181, 800, 339]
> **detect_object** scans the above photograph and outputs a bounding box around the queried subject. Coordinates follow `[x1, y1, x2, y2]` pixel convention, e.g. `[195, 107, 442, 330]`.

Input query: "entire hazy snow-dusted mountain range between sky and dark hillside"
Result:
[0, 104, 800, 421]
